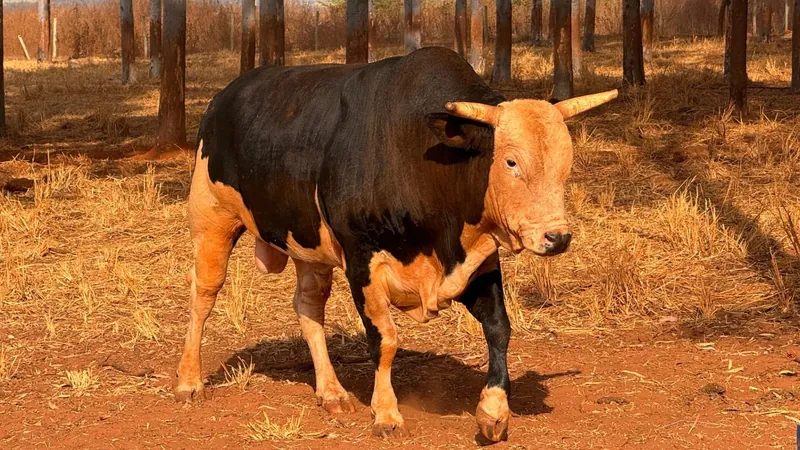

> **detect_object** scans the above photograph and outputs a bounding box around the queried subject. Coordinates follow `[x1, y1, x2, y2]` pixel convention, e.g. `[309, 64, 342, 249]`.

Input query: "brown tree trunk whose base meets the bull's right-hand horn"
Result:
[550, 0, 573, 101]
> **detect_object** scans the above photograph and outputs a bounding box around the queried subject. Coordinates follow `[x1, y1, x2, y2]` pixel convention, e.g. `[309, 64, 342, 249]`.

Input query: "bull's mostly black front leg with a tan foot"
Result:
[459, 253, 511, 442]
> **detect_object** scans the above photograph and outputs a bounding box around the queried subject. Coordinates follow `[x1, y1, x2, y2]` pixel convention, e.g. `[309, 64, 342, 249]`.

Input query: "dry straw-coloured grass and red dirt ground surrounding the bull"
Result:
[0, 39, 800, 449]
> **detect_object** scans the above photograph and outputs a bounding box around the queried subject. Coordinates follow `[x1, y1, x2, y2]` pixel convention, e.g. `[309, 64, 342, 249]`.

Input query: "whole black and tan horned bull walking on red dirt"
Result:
[175, 48, 616, 440]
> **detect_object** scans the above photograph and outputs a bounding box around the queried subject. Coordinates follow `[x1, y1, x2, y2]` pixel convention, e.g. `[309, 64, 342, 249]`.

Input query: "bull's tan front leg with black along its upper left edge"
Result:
[347, 264, 409, 438]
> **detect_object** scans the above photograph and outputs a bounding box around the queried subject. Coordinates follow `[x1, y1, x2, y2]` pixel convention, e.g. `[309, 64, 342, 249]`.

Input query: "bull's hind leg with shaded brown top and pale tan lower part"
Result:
[294, 259, 355, 413]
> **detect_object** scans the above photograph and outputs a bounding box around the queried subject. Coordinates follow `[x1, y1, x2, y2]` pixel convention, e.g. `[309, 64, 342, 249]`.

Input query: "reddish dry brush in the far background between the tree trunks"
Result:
[4, 0, 782, 58]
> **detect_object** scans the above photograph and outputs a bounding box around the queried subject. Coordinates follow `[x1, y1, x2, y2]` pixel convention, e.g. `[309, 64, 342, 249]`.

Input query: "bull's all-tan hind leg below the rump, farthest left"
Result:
[175, 192, 244, 402]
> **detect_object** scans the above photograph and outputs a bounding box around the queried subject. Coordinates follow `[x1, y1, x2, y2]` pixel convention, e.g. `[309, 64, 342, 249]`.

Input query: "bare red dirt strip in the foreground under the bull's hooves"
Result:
[0, 330, 800, 448]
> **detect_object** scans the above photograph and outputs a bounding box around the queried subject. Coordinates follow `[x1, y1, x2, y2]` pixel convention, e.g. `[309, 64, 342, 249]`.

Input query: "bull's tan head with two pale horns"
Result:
[432, 90, 617, 256]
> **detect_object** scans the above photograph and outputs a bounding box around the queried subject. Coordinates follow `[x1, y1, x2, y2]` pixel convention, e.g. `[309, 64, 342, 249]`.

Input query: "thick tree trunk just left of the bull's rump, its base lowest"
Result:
[158, 0, 186, 150]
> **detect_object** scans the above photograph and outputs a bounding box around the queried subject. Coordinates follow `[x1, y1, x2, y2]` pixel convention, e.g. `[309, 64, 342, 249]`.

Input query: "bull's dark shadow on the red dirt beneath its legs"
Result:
[209, 336, 579, 416]
